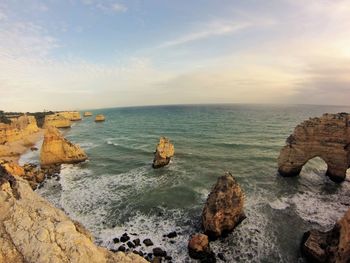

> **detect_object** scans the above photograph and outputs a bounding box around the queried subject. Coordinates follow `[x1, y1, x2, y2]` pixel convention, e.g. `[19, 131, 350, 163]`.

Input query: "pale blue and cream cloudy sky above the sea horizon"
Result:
[0, 0, 350, 111]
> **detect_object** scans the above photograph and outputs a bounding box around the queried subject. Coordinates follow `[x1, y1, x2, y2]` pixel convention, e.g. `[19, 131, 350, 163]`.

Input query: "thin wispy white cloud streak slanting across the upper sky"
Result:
[159, 21, 251, 48]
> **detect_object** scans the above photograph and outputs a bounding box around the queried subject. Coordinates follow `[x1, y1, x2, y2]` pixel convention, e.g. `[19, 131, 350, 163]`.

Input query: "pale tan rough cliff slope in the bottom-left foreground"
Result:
[0, 167, 147, 263]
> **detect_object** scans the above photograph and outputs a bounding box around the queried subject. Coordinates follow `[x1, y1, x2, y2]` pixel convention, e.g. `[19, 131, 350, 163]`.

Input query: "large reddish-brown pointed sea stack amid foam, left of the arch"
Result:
[202, 173, 246, 239]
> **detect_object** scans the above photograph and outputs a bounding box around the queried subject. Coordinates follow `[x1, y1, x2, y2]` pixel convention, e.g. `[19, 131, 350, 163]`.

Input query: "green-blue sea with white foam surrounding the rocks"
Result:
[20, 104, 350, 263]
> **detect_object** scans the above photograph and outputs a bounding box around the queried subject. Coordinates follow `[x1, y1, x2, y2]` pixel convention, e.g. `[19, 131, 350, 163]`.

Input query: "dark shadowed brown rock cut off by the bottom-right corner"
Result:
[301, 209, 350, 263]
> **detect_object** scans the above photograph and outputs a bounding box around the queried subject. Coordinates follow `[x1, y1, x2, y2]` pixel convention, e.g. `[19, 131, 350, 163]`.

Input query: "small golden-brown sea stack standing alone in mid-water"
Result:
[152, 137, 175, 168]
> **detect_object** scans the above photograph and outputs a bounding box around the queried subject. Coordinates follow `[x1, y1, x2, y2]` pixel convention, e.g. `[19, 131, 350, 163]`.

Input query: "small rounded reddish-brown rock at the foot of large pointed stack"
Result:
[187, 234, 216, 262]
